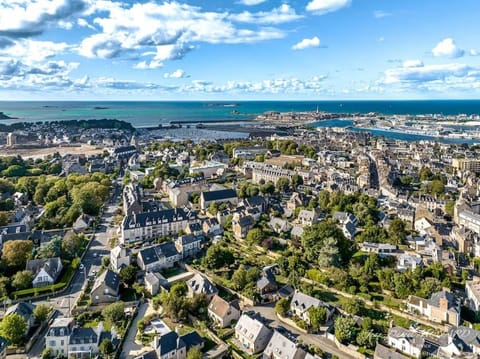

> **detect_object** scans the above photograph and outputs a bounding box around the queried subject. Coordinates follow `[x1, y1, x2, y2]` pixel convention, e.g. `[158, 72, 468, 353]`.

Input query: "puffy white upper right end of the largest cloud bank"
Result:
[229, 4, 303, 24]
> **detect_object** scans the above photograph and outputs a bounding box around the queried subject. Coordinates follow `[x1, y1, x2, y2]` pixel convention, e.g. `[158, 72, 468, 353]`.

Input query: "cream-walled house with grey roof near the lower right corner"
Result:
[407, 291, 460, 326]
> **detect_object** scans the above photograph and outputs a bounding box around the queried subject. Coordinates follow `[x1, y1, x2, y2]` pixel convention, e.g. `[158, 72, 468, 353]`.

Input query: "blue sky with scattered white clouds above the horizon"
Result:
[0, 0, 480, 100]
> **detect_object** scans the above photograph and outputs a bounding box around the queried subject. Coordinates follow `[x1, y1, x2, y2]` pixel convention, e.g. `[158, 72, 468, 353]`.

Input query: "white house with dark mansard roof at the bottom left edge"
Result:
[45, 318, 115, 358]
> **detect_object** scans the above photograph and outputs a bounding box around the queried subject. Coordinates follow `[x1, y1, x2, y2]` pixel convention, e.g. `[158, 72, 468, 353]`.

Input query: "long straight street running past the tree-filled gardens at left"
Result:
[27, 182, 121, 358]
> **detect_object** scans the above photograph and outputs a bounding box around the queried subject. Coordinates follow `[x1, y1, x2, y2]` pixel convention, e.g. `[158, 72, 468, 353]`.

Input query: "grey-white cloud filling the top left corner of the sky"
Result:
[0, 0, 88, 38]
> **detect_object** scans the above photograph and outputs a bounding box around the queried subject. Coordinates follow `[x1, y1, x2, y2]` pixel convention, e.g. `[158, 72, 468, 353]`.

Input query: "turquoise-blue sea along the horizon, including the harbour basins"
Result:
[0, 100, 480, 143]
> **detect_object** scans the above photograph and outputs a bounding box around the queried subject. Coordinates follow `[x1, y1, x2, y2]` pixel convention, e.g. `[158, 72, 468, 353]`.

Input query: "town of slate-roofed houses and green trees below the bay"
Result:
[0, 117, 480, 359]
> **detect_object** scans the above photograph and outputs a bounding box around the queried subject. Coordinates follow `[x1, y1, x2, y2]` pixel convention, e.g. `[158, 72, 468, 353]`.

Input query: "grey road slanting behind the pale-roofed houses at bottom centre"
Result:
[251, 304, 355, 359]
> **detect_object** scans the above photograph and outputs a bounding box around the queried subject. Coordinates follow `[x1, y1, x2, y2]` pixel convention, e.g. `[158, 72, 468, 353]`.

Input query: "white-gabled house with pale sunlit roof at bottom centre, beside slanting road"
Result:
[235, 314, 273, 355]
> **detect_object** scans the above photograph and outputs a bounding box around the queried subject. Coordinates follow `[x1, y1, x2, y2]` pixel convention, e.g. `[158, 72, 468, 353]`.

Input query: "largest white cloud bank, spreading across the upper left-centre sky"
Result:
[78, 2, 286, 64]
